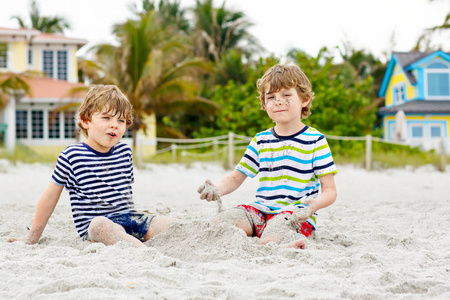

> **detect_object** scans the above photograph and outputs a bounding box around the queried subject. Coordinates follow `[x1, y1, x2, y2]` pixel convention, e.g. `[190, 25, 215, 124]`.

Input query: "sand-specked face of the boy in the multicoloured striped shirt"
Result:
[265, 88, 309, 125]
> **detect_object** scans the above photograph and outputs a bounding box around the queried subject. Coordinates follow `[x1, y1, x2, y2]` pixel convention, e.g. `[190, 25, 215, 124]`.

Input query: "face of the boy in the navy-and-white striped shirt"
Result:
[82, 108, 127, 153]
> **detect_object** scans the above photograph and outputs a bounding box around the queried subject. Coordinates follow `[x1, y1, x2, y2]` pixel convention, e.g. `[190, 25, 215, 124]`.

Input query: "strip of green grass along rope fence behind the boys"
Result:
[0, 139, 450, 169]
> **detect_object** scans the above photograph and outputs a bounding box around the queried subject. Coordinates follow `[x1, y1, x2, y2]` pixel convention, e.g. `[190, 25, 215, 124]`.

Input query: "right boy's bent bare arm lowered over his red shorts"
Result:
[291, 174, 337, 223]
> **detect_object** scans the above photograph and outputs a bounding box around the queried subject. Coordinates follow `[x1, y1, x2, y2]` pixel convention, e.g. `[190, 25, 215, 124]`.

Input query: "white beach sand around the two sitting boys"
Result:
[0, 160, 450, 299]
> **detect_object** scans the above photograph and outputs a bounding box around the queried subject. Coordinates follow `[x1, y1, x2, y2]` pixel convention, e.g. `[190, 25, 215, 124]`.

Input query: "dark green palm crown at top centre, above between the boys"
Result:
[193, 0, 261, 62]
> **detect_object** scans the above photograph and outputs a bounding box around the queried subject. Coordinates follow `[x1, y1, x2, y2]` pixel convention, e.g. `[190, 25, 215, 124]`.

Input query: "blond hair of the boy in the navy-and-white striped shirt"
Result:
[77, 84, 133, 137]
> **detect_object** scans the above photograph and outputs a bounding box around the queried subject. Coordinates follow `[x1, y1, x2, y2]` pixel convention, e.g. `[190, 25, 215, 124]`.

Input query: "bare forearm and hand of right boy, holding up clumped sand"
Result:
[197, 169, 247, 201]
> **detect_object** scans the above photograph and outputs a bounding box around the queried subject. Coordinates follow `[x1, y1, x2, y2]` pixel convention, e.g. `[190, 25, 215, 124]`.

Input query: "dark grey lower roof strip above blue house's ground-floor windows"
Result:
[378, 99, 450, 115]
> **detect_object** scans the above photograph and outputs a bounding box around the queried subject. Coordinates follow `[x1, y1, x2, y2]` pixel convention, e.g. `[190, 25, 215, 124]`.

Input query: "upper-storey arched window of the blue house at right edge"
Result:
[426, 62, 450, 97]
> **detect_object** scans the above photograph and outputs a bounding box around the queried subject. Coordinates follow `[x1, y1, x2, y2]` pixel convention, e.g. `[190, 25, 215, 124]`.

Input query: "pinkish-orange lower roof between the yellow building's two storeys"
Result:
[25, 77, 84, 99]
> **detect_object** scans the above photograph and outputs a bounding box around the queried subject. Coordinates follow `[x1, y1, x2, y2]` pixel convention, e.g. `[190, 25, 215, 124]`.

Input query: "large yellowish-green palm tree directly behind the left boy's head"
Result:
[82, 11, 217, 146]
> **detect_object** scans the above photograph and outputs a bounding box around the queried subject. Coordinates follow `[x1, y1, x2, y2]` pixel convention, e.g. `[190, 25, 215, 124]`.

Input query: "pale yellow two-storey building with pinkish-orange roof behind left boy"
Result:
[0, 28, 156, 159]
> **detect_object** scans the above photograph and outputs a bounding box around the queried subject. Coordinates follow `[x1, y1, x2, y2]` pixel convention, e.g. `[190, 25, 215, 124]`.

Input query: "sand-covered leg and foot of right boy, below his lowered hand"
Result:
[259, 214, 306, 249]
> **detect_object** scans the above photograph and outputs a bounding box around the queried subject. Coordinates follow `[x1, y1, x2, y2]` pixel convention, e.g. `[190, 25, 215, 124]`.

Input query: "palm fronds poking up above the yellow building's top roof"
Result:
[11, 0, 70, 33]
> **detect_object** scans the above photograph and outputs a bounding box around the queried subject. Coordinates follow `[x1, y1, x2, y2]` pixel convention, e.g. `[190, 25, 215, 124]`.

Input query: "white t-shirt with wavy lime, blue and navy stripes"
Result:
[236, 126, 337, 227]
